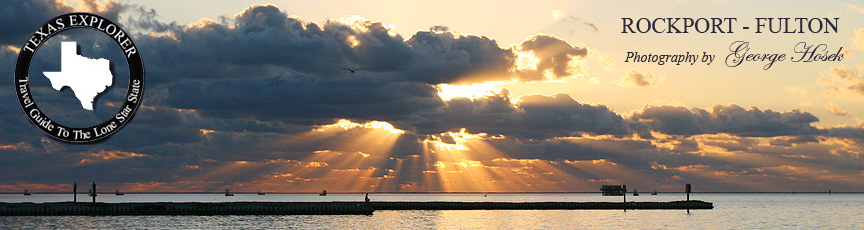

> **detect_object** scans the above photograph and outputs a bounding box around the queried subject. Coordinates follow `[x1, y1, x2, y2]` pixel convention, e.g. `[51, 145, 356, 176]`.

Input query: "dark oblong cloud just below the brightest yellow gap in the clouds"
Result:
[400, 89, 632, 139]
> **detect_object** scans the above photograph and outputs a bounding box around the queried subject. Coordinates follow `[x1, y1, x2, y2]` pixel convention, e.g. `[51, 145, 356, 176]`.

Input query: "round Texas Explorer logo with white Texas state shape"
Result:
[15, 13, 144, 143]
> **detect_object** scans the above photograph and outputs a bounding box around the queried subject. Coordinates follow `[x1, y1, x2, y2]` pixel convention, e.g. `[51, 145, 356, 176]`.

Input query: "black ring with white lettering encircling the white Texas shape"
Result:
[15, 12, 144, 143]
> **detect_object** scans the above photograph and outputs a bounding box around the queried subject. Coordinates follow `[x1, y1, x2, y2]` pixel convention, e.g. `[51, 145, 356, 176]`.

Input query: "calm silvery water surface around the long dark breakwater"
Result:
[0, 193, 864, 229]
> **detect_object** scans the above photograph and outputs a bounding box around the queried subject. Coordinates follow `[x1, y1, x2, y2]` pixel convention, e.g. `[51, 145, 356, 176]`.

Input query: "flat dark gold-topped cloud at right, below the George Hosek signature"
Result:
[630, 104, 824, 137]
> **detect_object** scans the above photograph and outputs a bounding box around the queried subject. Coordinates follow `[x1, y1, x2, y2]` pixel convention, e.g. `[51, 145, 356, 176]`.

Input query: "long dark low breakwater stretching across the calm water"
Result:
[0, 200, 714, 216]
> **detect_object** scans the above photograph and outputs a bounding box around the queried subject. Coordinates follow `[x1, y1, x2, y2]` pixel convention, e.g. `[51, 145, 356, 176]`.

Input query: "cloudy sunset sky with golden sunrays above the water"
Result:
[0, 0, 864, 193]
